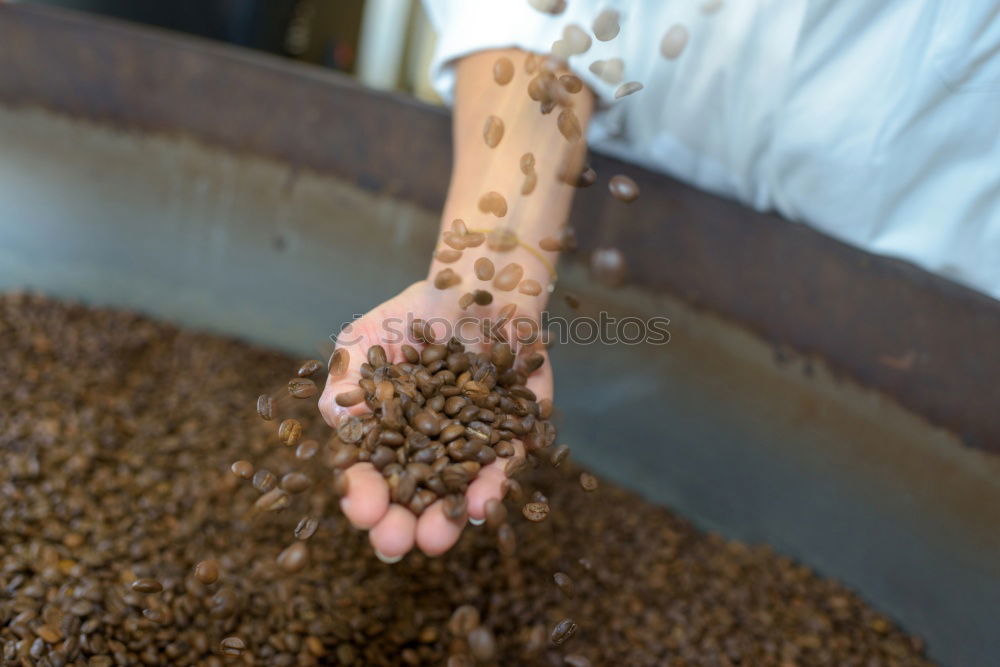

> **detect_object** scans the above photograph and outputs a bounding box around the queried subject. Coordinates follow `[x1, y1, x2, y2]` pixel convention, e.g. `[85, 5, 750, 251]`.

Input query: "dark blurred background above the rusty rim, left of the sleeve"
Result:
[16, 0, 440, 103]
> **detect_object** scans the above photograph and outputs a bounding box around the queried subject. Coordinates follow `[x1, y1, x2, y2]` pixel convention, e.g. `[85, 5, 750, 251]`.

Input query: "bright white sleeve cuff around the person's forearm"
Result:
[423, 0, 617, 105]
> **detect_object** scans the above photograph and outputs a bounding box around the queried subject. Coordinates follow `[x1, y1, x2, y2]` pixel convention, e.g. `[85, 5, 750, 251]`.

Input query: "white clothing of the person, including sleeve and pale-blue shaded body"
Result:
[424, 0, 1000, 298]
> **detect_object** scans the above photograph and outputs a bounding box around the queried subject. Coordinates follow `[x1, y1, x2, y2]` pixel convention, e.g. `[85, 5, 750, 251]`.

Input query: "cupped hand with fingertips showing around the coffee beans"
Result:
[319, 281, 552, 562]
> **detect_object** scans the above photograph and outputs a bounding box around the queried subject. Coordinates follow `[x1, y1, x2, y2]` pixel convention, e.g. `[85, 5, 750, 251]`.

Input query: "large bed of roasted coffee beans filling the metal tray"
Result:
[0, 294, 928, 667]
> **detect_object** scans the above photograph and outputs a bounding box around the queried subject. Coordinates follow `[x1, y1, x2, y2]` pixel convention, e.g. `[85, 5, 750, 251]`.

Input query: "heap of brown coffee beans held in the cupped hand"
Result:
[332, 340, 556, 520]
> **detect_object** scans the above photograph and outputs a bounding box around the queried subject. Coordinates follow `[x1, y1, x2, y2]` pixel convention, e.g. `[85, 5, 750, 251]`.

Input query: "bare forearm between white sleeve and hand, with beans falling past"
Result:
[429, 50, 593, 314]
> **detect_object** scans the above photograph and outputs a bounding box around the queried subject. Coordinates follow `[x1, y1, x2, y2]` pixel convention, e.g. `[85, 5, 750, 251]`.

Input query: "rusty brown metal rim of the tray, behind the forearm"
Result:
[0, 5, 1000, 452]
